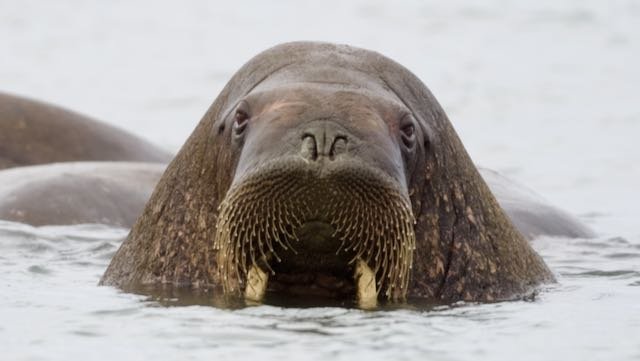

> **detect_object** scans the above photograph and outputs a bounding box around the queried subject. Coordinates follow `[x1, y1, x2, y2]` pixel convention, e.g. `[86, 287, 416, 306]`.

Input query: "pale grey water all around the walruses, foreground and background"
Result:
[0, 0, 640, 360]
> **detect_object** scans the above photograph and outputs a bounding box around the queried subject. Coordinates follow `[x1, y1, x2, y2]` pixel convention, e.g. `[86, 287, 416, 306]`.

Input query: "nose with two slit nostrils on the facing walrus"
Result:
[300, 121, 349, 161]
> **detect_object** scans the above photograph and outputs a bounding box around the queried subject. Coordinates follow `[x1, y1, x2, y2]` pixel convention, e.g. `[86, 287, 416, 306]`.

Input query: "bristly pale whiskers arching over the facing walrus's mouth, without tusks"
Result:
[215, 159, 413, 299]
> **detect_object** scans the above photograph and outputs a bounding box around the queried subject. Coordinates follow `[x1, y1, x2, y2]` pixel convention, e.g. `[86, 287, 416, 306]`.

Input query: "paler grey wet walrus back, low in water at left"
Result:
[0, 162, 166, 228]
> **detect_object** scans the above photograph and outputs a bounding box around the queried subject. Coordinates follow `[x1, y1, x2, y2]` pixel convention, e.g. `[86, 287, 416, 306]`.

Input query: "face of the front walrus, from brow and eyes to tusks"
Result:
[215, 83, 423, 306]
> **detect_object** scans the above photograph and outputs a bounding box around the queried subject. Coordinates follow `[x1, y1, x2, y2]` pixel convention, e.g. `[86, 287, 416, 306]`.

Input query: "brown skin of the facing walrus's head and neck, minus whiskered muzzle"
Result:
[101, 43, 553, 303]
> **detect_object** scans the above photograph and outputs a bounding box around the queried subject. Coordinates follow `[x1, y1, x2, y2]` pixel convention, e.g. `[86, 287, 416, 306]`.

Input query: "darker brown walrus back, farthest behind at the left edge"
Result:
[0, 93, 172, 169]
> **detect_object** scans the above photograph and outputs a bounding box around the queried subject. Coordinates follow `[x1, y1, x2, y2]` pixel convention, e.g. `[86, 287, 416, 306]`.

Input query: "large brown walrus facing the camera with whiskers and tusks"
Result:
[100, 42, 554, 308]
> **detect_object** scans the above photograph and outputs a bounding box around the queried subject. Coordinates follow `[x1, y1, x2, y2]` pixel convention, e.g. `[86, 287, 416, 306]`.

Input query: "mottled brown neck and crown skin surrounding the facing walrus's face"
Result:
[101, 43, 553, 303]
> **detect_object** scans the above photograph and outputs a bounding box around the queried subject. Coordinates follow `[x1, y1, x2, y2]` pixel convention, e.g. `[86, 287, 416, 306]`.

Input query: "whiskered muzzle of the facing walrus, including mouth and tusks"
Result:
[214, 157, 415, 307]
